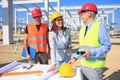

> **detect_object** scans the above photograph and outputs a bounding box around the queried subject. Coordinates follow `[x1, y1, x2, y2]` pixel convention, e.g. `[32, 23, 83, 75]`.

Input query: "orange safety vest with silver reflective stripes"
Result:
[27, 23, 48, 52]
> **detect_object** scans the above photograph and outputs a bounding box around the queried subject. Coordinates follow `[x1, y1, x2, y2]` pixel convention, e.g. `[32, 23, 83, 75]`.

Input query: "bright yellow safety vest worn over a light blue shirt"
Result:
[79, 22, 106, 68]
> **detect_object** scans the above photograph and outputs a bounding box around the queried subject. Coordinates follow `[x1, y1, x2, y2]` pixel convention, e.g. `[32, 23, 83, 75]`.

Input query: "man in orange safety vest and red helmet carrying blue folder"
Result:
[24, 8, 49, 64]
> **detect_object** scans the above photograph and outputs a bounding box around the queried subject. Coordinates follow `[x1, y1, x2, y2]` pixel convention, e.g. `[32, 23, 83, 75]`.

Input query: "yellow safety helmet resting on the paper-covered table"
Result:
[59, 63, 74, 77]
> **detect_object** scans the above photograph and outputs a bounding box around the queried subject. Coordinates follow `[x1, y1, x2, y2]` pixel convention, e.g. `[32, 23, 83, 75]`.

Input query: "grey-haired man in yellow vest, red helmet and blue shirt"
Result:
[69, 3, 111, 80]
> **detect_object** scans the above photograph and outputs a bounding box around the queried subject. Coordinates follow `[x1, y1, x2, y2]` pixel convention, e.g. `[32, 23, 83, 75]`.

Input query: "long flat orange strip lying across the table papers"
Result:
[0, 70, 42, 77]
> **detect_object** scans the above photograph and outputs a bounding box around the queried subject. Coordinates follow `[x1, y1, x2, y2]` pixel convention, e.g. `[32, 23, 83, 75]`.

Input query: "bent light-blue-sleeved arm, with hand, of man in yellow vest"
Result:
[72, 25, 111, 58]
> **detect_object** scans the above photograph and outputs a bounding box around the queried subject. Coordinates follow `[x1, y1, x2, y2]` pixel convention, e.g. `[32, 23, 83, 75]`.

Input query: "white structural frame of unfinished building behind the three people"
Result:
[0, 0, 120, 45]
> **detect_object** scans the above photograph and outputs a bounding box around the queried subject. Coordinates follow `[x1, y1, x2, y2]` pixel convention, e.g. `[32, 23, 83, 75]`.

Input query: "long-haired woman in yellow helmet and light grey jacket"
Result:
[48, 12, 71, 71]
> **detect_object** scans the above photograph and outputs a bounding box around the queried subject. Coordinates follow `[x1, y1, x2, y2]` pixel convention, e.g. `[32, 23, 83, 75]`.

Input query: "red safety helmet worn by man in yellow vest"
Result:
[78, 3, 98, 14]
